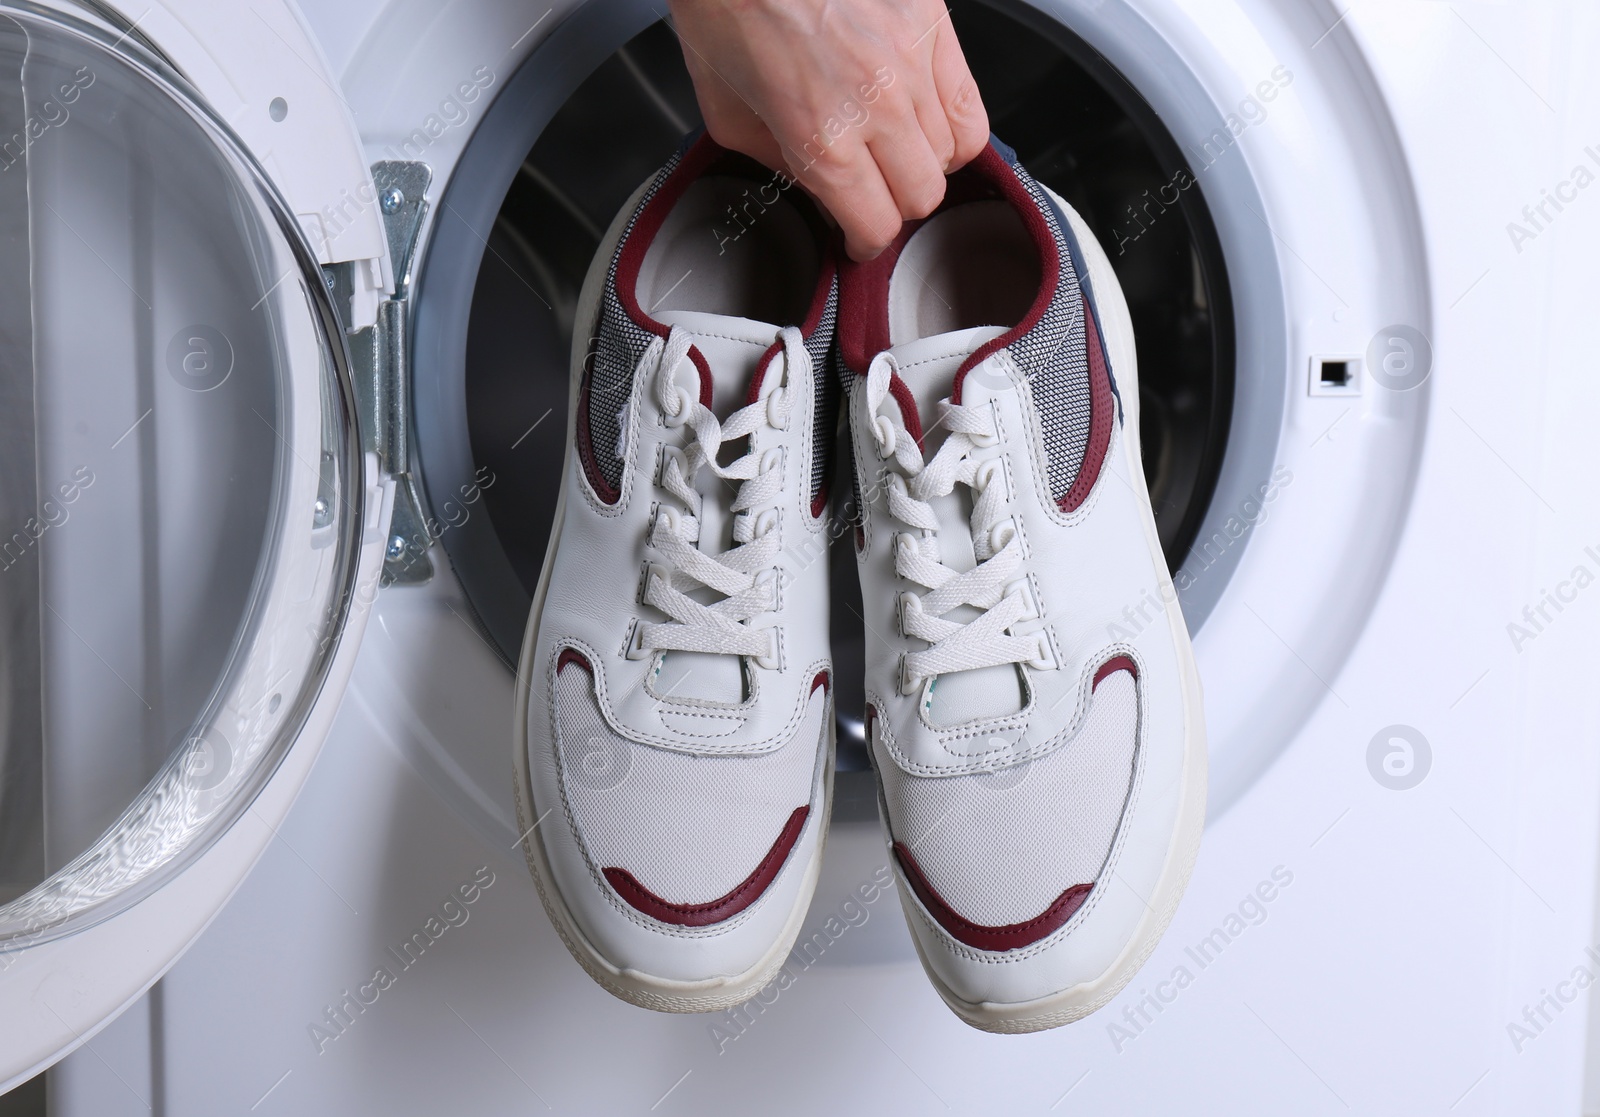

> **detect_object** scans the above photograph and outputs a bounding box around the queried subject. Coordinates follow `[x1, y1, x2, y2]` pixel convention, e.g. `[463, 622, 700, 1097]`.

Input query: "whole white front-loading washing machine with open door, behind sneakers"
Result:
[0, 0, 1600, 1117]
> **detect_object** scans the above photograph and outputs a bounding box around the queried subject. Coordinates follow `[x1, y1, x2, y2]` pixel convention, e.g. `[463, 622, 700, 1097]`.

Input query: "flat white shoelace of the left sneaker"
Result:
[632, 326, 811, 667]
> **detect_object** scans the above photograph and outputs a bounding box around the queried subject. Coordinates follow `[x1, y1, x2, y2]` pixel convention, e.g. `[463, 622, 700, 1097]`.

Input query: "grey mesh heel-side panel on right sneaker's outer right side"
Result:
[1008, 166, 1093, 501]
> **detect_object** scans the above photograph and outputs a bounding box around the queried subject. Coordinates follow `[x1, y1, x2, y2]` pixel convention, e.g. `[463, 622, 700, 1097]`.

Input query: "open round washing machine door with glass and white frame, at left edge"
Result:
[0, 2, 382, 1090]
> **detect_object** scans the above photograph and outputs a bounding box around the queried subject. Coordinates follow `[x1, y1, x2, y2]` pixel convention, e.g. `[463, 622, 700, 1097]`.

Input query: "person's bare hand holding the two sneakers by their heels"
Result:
[669, 0, 989, 259]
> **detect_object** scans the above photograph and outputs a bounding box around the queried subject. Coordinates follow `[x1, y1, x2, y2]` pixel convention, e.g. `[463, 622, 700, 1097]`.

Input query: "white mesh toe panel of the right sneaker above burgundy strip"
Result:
[878, 671, 1139, 927]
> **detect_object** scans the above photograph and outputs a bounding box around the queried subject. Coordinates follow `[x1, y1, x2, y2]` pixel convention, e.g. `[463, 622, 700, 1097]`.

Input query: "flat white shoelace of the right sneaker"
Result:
[867, 354, 1050, 695]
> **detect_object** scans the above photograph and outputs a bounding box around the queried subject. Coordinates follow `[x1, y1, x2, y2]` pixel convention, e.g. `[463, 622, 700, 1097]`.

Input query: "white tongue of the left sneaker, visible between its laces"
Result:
[651, 310, 778, 706]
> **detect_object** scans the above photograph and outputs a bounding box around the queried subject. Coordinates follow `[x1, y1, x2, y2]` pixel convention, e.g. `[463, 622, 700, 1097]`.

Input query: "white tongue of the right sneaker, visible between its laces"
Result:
[890, 326, 1027, 725]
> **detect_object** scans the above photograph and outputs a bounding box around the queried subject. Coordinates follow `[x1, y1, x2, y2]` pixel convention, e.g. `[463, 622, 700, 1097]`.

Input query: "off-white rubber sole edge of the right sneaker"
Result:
[896, 187, 1208, 1034]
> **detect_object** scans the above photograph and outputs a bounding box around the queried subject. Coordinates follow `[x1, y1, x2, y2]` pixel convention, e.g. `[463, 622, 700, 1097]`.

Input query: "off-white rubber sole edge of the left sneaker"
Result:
[512, 181, 834, 1013]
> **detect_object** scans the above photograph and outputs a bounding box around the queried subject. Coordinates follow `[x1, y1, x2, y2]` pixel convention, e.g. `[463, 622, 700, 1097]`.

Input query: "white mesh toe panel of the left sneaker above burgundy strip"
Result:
[555, 669, 827, 904]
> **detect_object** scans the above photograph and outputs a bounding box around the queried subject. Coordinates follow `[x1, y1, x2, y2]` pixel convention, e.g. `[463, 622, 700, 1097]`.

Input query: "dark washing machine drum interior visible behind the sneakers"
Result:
[416, 5, 1234, 770]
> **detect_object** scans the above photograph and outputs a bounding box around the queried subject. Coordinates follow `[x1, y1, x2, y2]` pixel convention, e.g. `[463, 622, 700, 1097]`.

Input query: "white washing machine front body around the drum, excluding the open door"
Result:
[40, 0, 1600, 1114]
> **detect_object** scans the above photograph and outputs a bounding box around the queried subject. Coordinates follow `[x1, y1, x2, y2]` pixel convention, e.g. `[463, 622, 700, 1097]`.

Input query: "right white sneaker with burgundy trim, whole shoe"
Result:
[838, 144, 1206, 1032]
